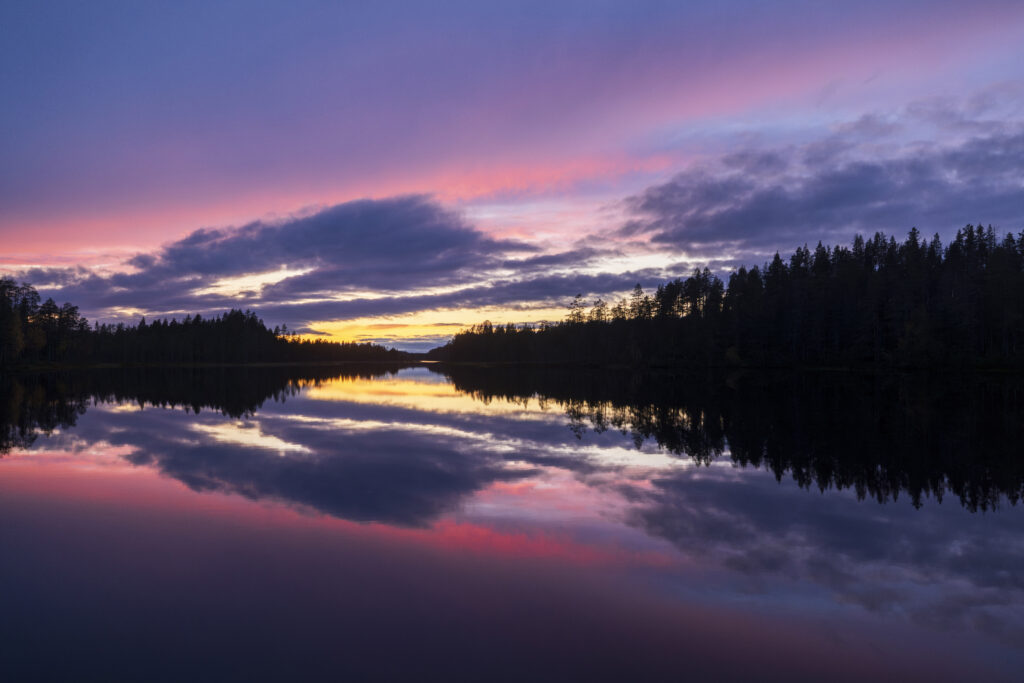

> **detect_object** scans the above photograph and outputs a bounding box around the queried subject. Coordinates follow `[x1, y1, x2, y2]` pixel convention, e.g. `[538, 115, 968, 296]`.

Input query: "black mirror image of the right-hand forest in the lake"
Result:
[434, 365, 1024, 511]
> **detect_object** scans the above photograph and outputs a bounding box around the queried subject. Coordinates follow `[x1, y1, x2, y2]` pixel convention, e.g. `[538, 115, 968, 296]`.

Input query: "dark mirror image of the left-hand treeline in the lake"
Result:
[0, 364, 415, 455]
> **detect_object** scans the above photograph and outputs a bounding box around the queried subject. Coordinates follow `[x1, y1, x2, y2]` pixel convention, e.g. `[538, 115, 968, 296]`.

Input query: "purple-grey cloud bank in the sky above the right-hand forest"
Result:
[618, 127, 1024, 256]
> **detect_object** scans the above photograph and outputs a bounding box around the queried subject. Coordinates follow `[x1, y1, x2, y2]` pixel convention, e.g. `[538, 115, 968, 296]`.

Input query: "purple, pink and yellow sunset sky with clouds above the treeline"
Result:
[0, 0, 1024, 350]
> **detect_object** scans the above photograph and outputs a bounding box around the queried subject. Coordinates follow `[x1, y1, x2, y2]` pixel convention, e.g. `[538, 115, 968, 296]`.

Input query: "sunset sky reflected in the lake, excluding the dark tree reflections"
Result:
[0, 367, 1024, 680]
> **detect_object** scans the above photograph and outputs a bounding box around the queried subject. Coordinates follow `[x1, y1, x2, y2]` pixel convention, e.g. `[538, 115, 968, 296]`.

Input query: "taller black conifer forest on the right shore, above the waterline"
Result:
[430, 225, 1024, 368]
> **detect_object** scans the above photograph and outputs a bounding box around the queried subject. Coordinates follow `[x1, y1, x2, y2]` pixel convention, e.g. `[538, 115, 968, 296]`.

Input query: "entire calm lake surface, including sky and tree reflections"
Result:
[0, 366, 1024, 681]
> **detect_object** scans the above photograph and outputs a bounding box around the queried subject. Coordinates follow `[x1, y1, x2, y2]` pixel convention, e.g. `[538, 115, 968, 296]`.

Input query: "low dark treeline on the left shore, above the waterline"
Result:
[0, 279, 407, 368]
